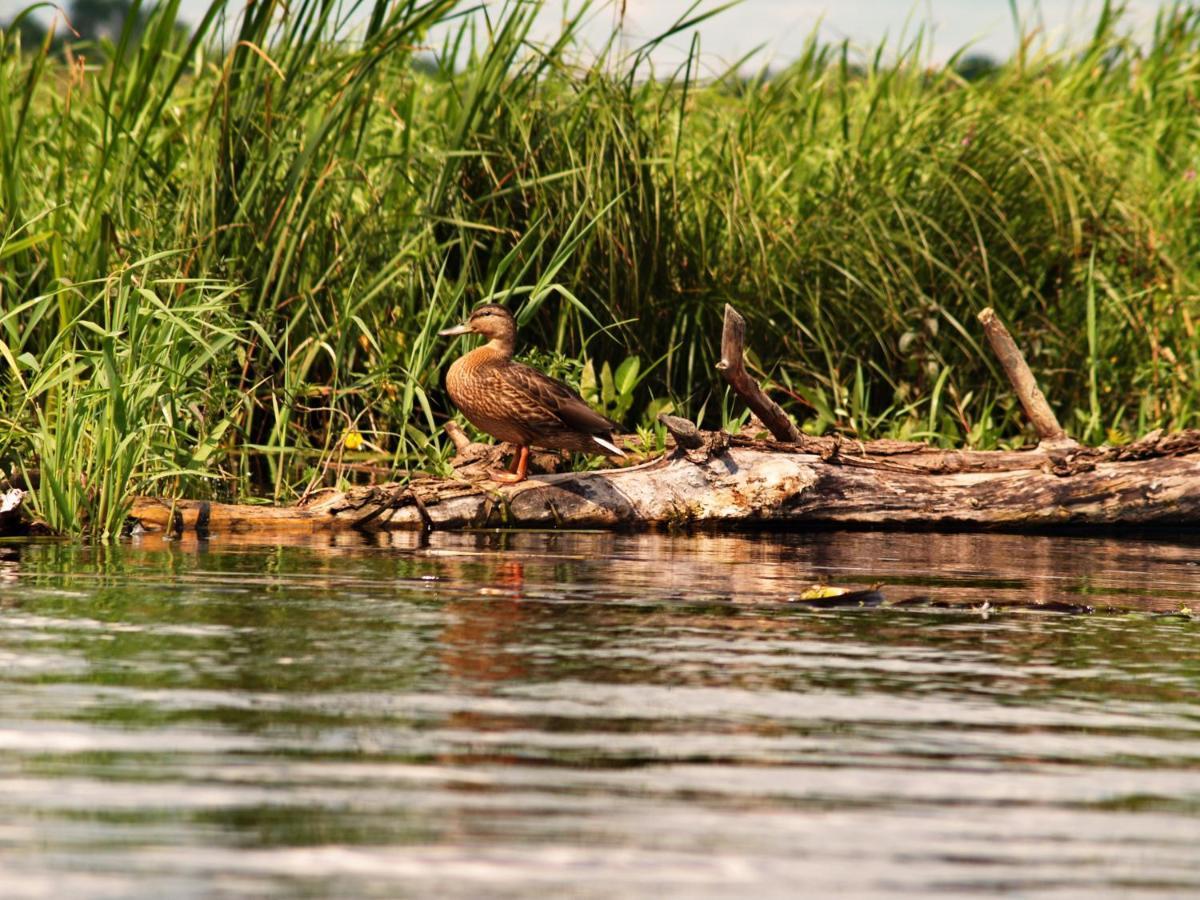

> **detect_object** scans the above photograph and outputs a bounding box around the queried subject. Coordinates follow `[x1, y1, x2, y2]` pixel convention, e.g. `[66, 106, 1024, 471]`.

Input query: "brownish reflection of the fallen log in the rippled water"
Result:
[357, 532, 1200, 612]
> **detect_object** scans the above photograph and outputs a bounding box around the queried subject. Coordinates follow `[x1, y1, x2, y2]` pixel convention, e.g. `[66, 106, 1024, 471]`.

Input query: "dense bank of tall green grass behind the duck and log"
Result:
[0, 0, 1200, 534]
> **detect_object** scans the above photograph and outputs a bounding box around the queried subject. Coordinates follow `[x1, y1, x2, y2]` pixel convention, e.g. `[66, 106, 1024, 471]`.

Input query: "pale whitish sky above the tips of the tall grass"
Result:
[0, 0, 1159, 65]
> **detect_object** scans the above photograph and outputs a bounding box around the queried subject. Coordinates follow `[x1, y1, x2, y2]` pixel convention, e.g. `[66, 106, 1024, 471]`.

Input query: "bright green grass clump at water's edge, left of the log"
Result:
[0, 250, 238, 538]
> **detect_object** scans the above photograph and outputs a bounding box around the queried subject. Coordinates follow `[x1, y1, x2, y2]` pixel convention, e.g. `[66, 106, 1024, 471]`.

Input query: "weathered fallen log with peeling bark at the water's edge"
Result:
[133, 431, 1200, 534]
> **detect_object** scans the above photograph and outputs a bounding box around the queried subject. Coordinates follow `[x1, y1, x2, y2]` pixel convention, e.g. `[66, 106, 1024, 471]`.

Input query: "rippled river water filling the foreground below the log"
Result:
[0, 533, 1200, 898]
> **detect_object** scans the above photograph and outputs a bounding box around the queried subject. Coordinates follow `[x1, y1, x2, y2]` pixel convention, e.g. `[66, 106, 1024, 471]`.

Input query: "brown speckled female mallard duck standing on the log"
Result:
[438, 304, 624, 484]
